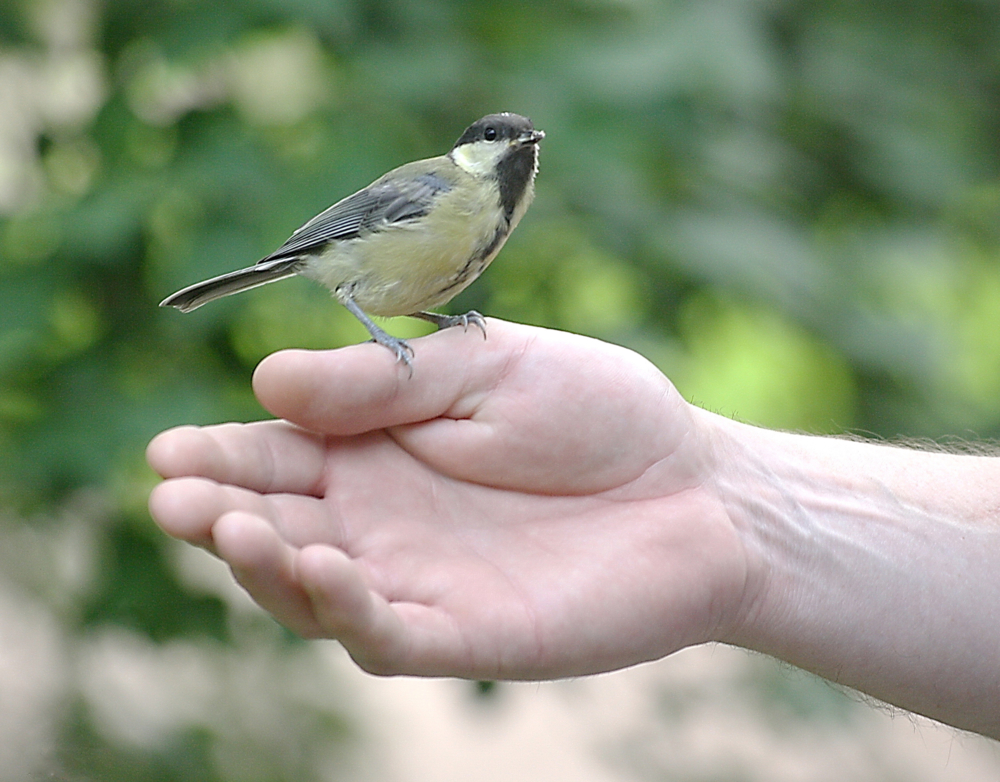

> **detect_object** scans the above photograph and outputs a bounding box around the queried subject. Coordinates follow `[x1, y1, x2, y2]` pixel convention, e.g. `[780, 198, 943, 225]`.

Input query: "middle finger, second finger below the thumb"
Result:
[149, 478, 346, 548]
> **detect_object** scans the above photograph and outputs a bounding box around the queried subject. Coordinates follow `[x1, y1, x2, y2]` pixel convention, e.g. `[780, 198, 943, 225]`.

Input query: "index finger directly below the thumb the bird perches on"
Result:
[146, 421, 325, 496]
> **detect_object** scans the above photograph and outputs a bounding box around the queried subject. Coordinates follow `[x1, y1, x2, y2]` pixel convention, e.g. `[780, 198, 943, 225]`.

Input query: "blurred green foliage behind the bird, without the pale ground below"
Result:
[0, 0, 1000, 779]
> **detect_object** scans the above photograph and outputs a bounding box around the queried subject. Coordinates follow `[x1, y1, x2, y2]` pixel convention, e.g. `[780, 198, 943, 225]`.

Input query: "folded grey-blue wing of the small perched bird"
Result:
[259, 166, 452, 263]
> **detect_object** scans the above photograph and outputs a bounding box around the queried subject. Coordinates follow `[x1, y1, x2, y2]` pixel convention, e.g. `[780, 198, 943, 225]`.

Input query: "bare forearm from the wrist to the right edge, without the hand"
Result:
[706, 414, 1000, 738]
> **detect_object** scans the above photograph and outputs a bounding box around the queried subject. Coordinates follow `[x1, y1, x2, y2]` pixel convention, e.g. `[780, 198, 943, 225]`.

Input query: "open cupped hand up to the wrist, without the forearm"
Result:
[147, 320, 748, 679]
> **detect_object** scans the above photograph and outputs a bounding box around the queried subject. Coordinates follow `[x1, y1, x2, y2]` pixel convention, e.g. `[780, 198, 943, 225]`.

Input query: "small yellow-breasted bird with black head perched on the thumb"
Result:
[160, 113, 545, 371]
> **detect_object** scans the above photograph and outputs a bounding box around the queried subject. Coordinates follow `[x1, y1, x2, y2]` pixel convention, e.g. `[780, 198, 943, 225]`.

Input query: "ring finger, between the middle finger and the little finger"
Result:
[212, 512, 323, 638]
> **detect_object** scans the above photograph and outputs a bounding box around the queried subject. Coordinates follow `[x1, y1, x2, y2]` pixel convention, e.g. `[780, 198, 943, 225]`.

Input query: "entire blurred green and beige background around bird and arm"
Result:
[0, 0, 1000, 782]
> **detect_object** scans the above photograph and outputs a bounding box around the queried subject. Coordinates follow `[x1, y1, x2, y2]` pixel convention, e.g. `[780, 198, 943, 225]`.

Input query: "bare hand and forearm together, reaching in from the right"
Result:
[147, 320, 1000, 737]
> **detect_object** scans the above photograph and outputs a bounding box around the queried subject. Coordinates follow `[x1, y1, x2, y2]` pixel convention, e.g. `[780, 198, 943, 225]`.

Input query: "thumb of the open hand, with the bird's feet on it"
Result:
[253, 318, 530, 435]
